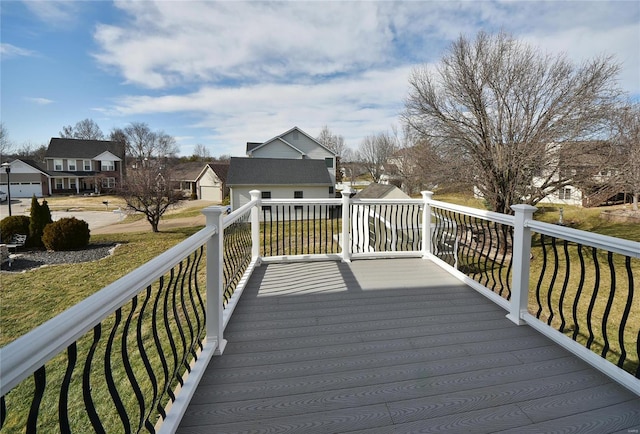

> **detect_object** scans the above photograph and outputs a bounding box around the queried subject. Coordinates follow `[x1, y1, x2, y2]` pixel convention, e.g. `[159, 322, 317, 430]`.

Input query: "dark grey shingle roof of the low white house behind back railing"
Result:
[227, 158, 333, 186]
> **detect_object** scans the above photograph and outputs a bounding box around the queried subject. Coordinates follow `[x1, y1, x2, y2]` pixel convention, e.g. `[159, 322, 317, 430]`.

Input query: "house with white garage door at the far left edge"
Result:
[0, 158, 51, 198]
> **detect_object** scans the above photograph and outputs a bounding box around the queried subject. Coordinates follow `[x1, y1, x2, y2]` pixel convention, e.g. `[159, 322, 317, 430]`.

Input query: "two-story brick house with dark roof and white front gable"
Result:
[45, 137, 125, 194]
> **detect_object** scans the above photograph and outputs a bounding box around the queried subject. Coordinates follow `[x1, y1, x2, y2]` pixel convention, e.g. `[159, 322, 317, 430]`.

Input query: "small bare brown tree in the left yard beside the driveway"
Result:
[118, 161, 184, 232]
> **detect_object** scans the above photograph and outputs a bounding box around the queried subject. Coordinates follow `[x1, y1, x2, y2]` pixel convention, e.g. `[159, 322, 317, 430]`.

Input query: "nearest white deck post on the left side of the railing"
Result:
[202, 206, 227, 355]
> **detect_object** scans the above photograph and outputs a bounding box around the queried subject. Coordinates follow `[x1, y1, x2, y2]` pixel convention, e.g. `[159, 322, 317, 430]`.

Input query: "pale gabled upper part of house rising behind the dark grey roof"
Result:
[247, 127, 337, 184]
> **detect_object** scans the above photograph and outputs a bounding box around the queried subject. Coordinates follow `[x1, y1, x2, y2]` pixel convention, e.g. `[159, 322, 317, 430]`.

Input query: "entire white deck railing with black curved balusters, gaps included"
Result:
[0, 191, 640, 432]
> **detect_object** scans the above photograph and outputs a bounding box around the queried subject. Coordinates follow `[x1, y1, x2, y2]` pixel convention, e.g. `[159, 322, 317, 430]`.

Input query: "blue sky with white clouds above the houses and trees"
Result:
[0, 0, 640, 156]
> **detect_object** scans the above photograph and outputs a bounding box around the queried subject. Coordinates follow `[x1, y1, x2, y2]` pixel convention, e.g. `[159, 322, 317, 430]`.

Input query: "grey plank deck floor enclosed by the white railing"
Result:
[178, 259, 640, 434]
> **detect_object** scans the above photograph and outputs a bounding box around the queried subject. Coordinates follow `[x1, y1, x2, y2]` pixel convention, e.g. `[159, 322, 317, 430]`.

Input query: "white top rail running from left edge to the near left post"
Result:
[0, 226, 217, 396]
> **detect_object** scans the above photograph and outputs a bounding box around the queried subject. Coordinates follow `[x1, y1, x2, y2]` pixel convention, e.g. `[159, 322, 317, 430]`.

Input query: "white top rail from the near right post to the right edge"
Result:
[525, 220, 640, 258]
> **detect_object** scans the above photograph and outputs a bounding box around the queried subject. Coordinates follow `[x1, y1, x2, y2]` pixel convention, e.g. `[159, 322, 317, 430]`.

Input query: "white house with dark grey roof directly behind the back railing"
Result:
[227, 157, 335, 209]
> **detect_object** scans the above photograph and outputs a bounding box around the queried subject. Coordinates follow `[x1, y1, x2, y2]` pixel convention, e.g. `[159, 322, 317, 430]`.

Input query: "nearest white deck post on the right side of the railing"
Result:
[507, 205, 538, 325]
